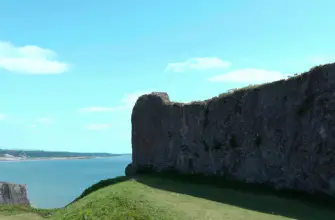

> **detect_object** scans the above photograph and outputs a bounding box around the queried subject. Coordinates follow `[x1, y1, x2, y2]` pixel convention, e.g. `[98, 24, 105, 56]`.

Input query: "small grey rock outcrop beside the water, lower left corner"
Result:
[0, 182, 30, 205]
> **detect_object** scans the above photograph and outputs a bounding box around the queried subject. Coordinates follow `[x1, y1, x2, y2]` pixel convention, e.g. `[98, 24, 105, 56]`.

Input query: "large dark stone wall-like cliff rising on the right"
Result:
[132, 64, 335, 196]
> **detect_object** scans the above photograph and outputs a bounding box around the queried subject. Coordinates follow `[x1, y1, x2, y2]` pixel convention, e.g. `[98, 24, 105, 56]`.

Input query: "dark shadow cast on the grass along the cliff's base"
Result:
[134, 172, 335, 220]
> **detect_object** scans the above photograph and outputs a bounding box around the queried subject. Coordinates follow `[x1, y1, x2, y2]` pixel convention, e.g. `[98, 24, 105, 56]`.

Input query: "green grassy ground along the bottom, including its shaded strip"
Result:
[0, 174, 335, 220]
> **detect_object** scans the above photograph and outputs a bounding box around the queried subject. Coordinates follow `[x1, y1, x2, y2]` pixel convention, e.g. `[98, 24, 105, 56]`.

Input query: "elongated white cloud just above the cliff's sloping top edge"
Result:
[208, 68, 285, 83]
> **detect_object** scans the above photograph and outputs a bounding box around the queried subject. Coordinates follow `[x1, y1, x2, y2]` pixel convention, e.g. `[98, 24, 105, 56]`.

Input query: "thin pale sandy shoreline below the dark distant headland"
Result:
[0, 155, 118, 162]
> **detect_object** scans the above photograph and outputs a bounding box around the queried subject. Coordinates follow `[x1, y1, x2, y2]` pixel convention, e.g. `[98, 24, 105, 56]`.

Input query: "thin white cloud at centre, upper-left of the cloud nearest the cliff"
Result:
[165, 57, 231, 73]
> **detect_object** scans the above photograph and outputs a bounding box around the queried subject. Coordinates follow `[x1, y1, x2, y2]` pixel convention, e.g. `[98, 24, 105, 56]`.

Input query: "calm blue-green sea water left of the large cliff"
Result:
[0, 155, 131, 208]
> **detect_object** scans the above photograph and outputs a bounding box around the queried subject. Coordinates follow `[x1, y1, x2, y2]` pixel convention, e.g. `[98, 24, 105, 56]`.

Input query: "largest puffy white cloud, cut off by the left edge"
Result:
[0, 41, 69, 74]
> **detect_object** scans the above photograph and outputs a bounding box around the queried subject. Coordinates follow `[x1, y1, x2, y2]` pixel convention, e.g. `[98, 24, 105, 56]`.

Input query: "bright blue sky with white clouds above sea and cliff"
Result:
[0, 0, 335, 153]
